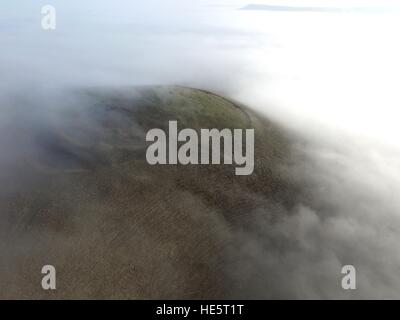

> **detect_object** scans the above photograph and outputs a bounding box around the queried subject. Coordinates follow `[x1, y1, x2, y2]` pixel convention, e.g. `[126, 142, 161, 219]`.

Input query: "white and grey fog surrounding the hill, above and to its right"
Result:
[0, 0, 400, 298]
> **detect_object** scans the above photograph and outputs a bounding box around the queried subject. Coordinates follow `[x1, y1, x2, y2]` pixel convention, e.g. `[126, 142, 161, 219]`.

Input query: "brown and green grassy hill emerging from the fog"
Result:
[0, 87, 299, 299]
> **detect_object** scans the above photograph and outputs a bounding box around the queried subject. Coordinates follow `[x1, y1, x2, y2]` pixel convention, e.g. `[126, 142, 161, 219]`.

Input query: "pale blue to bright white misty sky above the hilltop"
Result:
[0, 0, 400, 143]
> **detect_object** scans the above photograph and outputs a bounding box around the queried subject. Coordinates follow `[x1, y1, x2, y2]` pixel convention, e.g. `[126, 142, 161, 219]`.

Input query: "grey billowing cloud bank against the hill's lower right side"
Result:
[223, 136, 400, 299]
